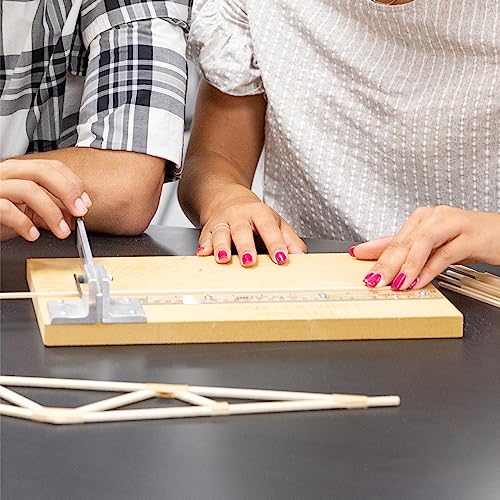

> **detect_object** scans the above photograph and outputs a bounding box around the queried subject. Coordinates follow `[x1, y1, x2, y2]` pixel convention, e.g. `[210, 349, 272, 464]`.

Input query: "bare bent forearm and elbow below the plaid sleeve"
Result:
[20, 147, 165, 234]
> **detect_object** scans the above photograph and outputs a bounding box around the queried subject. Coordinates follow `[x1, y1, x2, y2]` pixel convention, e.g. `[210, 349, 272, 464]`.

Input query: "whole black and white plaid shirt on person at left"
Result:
[0, 0, 192, 178]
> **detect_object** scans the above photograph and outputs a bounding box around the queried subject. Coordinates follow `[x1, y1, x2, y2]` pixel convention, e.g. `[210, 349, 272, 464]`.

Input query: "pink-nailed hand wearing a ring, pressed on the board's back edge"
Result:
[197, 185, 307, 267]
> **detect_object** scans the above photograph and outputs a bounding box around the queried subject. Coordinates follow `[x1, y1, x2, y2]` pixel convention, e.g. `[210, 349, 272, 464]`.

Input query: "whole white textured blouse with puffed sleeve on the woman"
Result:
[189, 0, 500, 241]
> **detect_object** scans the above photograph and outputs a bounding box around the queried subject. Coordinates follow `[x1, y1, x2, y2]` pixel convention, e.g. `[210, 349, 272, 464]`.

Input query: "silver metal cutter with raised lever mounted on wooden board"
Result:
[47, 218, 147, 324]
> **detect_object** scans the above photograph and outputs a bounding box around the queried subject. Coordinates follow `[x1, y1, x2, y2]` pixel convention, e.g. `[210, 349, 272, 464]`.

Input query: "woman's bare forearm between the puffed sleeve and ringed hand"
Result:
[179, 81, 266, 225]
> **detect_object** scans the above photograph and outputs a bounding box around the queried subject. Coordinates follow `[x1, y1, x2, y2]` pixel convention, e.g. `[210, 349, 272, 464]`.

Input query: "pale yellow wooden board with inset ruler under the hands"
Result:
[27, 254, 463, 346]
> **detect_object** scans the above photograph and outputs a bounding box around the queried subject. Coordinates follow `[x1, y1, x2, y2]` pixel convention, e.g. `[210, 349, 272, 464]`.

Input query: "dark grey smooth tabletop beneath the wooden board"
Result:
[0, 227, 500, 500]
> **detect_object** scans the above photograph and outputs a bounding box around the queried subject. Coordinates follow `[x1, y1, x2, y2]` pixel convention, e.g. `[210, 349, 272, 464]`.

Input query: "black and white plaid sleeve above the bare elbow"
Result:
[77, 0, 191, 180]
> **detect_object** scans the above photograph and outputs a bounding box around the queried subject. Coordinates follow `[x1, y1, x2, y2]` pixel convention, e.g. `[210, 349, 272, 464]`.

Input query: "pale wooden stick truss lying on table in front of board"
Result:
[0, 376, 400, 425]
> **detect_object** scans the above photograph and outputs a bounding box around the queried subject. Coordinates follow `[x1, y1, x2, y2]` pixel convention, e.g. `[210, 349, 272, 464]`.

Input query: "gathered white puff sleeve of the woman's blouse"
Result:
[188, 0, 264, 96]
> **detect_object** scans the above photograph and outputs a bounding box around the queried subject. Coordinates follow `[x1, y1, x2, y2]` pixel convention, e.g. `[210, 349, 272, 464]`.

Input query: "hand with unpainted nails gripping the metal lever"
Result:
[0, 160, 92, 241]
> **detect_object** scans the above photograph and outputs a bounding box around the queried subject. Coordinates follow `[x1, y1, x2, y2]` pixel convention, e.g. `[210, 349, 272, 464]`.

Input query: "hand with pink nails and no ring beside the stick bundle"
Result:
[350, 206, 500, 290]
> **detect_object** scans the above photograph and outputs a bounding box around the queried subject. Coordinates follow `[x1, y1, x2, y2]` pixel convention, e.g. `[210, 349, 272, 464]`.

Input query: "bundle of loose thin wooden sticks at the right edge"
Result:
[438, 266, 500, 308]
